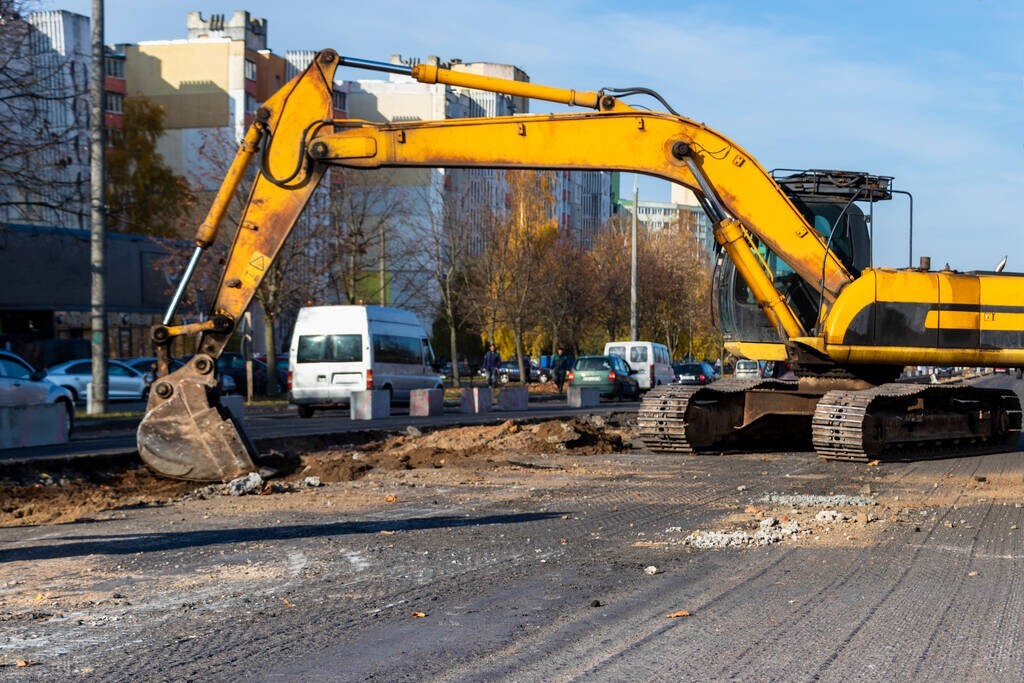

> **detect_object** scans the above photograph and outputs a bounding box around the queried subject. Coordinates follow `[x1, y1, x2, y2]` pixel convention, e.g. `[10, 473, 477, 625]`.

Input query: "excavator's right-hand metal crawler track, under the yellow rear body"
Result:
[812, 383, 1021, 462]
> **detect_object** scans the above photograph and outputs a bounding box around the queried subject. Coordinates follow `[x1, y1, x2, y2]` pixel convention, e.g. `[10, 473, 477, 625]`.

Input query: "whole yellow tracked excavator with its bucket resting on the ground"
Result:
[138, 50, 1024, 480]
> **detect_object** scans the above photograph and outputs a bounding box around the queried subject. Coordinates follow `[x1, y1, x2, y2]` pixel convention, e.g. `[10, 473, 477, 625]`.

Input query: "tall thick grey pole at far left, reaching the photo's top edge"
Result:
[87, 0, 108, 415]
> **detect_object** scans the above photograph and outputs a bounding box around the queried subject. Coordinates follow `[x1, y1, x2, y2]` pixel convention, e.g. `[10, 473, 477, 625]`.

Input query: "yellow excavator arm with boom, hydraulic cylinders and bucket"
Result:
[138, 50, 852, 480]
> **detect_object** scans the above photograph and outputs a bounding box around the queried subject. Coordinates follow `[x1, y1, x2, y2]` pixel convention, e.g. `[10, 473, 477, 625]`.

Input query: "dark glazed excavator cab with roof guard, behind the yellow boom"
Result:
[713, 169, 892, 352]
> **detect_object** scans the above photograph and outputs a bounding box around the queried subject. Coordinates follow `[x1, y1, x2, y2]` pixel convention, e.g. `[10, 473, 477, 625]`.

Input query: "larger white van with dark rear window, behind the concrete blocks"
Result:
[288, 306, 444, 418]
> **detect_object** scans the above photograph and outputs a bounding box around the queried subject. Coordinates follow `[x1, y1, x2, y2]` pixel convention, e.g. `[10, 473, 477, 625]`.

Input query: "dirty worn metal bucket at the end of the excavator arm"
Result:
[137, 355, 257, 481]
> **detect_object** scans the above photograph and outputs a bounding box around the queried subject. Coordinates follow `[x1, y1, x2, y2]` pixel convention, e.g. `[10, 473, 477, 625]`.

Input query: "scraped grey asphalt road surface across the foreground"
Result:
[0, 377, 1024, 681]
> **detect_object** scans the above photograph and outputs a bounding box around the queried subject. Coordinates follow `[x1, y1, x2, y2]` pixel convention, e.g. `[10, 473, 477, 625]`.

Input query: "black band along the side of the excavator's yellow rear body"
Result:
[843, 301, 1024, 349]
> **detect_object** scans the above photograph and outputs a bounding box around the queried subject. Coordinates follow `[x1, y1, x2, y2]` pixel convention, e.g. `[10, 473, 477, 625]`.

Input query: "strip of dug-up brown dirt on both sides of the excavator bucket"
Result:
[0, 417, 632, 526]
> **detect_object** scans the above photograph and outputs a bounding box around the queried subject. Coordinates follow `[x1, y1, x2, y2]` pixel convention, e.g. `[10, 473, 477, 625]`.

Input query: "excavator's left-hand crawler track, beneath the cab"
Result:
[637, 379, 817, 454]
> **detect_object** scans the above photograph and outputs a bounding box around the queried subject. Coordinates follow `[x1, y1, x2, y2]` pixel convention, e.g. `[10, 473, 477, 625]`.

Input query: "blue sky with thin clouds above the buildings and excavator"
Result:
[49, 0, 1024, 272]
